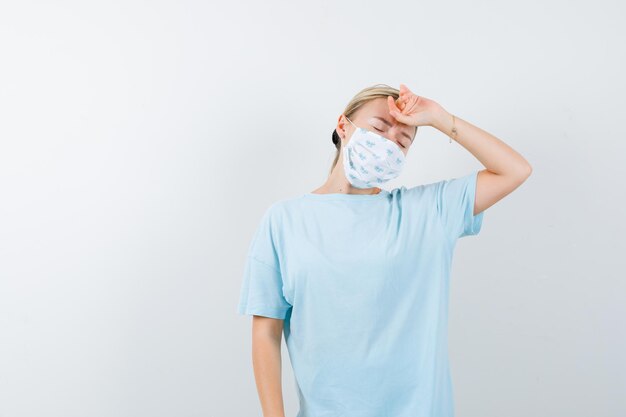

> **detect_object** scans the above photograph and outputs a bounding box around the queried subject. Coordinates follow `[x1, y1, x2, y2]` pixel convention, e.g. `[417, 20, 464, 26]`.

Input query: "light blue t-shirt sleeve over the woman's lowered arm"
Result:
[237, 207, 291, 319]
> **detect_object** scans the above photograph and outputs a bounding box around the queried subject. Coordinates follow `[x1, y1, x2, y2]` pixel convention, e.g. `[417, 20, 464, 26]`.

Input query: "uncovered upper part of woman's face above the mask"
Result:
[337, 97, 417, 155]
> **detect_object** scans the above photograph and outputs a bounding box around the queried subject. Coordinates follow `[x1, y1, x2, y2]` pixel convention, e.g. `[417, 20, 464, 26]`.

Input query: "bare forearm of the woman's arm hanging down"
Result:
[252, 334, 285, 417]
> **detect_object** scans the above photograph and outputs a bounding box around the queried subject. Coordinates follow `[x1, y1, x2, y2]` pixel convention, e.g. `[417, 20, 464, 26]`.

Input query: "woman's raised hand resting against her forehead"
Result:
[387, 84, 445, 127]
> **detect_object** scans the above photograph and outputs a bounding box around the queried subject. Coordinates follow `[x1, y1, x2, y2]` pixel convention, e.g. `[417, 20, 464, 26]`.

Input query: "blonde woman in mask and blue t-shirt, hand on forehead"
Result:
[238, 84, 531, 417]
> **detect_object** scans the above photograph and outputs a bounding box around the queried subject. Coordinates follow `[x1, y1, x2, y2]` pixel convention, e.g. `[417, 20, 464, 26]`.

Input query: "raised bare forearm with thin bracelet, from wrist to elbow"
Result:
[432, 110, 532, 177]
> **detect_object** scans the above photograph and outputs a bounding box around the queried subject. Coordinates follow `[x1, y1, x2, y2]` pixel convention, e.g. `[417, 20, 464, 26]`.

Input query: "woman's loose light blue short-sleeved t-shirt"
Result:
[238, 171, 484, 417]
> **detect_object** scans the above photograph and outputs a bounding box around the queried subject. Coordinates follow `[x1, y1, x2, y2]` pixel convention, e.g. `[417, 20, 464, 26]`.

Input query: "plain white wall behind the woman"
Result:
[0, 0, 626, 417]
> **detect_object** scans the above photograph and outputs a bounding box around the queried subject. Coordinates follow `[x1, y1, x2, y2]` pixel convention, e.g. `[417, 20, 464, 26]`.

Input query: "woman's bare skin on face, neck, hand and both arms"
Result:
[252, 84, 532, 417]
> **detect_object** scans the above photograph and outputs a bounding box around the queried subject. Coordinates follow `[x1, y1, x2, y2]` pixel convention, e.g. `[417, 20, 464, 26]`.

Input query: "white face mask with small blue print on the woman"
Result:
[343, 117, 405, 188]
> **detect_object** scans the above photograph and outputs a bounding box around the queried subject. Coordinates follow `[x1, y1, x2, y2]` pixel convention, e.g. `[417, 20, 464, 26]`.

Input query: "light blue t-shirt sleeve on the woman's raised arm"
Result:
[435, 171, 485, 241]
